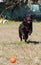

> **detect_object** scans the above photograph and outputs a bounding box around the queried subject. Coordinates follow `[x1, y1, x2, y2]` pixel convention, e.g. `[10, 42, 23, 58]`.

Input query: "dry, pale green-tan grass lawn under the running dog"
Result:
[0, 21, 41, 65]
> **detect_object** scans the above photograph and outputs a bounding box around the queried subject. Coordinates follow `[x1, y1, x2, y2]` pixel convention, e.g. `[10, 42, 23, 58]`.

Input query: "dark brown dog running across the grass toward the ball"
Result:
[19, 15, 32, 42]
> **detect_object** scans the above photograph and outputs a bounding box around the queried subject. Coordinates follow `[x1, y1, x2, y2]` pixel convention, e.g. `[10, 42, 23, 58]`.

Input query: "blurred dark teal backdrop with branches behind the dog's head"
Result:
[0, 0, 41, 20]
